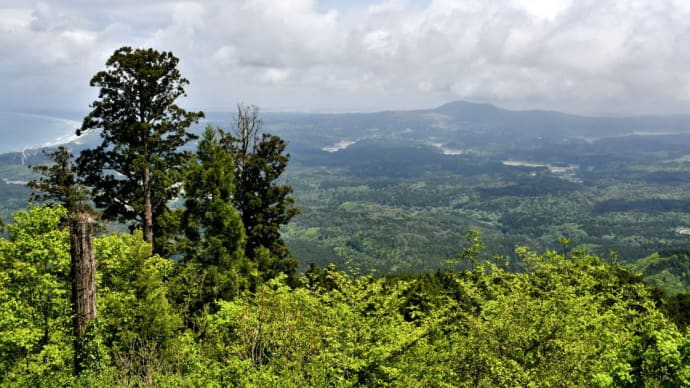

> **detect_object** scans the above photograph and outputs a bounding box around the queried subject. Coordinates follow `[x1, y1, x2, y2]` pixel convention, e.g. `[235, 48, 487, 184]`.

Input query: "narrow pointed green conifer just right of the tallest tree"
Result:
[179, 127, 253, 311]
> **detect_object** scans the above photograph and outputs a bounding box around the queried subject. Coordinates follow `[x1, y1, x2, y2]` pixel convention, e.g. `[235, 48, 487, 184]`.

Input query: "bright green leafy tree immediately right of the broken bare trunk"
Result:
[94, 232, 182, 385]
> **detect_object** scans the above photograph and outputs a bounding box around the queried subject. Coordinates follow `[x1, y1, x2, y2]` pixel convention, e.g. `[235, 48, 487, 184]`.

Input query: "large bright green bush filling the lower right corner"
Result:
[435, 248, 690, 386]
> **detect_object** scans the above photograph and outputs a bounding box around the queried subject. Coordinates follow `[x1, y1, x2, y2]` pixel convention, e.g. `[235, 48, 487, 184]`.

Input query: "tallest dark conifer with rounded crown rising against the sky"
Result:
[77, 47, 203, 251]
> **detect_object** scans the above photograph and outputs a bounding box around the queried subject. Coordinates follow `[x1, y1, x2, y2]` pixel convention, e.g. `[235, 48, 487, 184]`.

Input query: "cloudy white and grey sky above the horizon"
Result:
[0, 0, 690, 115]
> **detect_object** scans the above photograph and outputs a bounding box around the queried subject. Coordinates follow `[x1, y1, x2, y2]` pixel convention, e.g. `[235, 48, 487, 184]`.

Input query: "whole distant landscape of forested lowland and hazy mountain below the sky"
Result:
[0, 101, 690, 290]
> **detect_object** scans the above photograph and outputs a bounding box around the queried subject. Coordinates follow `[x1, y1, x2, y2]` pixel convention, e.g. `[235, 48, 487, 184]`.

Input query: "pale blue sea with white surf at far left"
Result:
[0, 112, 81, 153]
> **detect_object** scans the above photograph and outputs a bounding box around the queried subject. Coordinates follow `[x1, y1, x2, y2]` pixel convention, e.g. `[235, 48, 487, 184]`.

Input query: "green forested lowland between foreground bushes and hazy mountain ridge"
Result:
[278, 136, 690, 273]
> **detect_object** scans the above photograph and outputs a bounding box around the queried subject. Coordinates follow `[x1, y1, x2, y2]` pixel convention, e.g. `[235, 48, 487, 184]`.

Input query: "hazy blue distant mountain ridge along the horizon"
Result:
[1, 101, 690, 158]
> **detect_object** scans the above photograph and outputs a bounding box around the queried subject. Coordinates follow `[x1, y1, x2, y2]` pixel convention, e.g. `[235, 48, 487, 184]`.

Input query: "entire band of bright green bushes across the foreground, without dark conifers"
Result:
[0, 206, 690, 387]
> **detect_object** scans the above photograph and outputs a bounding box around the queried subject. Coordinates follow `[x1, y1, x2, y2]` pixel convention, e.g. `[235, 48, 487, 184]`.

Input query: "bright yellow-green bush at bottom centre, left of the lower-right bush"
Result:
[211, 271, 426, 386]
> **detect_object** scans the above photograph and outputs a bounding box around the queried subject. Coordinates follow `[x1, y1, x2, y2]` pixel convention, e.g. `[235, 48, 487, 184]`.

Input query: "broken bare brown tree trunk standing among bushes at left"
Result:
[69, 212, 96, 375]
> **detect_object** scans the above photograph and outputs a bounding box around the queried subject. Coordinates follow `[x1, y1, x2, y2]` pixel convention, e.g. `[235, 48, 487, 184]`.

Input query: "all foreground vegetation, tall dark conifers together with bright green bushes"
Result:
[0, 47, 690, 387]
